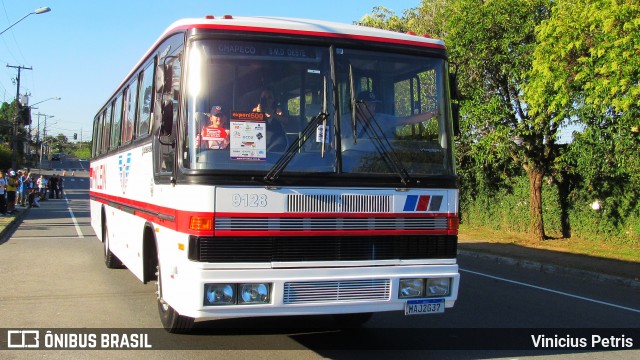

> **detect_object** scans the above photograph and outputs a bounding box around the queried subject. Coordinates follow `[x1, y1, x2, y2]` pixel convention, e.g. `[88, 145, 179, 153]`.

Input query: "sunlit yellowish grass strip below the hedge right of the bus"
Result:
[459, 226, 640, 263]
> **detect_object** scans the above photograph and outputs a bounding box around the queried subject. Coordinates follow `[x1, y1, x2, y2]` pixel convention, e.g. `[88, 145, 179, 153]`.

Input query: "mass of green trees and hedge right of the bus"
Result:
[361, 0, 640, 239]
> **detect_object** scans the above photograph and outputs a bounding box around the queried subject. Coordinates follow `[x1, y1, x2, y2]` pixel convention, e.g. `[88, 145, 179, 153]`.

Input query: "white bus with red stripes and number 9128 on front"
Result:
[90, 16, 459, 332]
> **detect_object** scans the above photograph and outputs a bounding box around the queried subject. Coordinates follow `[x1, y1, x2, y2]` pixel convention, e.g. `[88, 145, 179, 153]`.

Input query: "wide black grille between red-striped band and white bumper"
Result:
[189, 235, 458, 263]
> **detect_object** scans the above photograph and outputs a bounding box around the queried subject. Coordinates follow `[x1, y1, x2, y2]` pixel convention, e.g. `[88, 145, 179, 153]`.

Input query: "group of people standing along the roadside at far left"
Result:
[0, 169, 64, 216]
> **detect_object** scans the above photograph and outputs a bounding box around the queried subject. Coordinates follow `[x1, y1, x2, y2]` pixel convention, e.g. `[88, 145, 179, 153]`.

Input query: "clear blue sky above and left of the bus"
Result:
[0, 0, 421, 141]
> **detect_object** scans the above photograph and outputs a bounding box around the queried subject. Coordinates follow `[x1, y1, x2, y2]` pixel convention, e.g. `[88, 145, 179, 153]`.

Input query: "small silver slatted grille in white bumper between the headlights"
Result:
[283, 279, 391, 304]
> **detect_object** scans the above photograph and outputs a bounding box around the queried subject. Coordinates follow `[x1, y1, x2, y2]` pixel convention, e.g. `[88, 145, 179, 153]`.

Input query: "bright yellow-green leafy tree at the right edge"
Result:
[526, 0, 640, 242]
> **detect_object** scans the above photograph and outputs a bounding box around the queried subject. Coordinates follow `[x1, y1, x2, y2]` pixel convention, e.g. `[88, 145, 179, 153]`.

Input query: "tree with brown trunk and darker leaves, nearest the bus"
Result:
[445, 0, 560, 240]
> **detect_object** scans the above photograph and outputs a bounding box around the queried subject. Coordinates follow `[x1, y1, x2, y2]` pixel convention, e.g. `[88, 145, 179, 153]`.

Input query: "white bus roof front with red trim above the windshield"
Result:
[163, 15, 444, 49]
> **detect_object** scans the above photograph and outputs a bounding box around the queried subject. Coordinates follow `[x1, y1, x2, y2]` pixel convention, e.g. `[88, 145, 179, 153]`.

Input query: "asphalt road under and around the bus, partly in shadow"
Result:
[0, 174, 640, 359]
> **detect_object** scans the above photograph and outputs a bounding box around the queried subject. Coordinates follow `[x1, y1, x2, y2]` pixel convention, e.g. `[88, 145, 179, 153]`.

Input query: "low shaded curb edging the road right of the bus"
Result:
[458, 249, 640, 289]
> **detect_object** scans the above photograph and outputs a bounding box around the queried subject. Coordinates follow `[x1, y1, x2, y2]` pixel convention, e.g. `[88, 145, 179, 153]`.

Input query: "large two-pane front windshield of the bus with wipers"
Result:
[181, 39, 454, 178]
